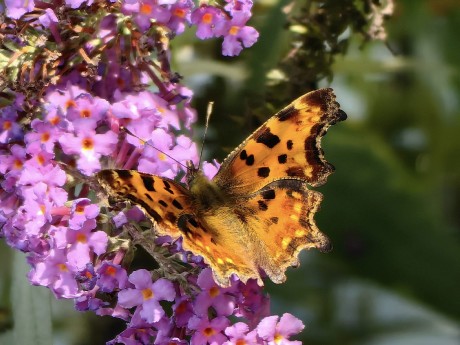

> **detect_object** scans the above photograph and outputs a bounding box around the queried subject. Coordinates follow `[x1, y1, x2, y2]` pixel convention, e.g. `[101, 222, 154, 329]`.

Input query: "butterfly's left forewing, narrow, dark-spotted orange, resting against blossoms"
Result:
[96, 170, 191, 238]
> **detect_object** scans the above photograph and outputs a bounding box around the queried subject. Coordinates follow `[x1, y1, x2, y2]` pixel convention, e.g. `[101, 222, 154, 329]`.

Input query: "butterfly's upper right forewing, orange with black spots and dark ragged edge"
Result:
[213, 89, 346, 195]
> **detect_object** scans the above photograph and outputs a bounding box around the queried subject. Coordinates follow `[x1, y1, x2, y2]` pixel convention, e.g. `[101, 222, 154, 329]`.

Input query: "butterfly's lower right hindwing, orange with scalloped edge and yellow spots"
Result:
[235, 179, 332, 283]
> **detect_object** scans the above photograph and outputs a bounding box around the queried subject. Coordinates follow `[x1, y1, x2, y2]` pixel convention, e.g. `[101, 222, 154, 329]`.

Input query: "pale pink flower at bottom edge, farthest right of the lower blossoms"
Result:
[257, 313, 305, 345]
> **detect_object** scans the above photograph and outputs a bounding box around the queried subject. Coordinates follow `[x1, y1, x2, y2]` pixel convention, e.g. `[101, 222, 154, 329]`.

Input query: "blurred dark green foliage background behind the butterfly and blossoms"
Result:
[0, 0, 460, 345]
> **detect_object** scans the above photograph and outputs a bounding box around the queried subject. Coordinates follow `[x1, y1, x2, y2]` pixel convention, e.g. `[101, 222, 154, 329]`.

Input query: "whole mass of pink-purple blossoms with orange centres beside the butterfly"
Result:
[0, 0, 304, 345]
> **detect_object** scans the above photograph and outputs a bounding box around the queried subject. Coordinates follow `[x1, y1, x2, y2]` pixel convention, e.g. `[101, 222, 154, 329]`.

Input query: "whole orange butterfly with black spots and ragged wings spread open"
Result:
[96, 88, 347, 287]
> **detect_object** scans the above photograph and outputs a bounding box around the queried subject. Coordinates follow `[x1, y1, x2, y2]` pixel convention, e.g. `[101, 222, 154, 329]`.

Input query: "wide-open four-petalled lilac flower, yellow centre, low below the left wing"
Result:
[118, 269, 176, 323]
